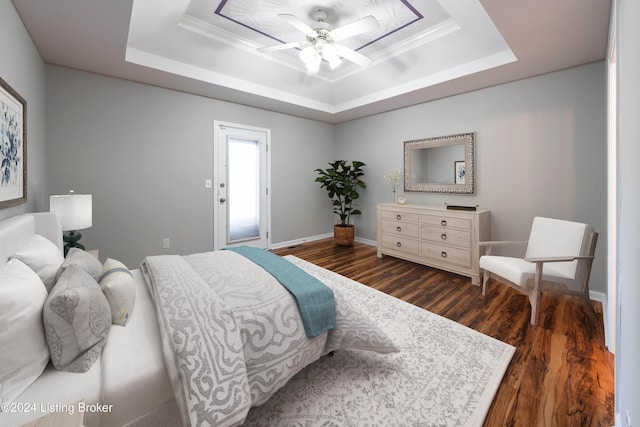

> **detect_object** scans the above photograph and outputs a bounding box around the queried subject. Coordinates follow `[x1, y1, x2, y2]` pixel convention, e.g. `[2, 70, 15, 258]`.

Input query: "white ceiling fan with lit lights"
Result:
[258, 9, 378, 74]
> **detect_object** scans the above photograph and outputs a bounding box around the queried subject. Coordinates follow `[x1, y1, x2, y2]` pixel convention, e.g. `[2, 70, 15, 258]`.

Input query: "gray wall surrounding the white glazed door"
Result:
[47, 66, 335, 268]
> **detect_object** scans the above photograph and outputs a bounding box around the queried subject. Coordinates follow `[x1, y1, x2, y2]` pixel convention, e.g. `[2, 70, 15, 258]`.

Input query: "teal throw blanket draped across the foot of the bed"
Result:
[227, 246, 336, 338]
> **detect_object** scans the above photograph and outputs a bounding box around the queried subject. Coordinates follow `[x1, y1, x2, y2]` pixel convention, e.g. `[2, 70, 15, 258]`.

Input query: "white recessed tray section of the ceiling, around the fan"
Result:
[126, 0, 516, 114]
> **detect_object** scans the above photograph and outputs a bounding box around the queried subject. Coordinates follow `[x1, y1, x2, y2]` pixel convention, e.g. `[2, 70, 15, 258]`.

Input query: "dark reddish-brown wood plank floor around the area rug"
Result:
[274, 239, 614, 426]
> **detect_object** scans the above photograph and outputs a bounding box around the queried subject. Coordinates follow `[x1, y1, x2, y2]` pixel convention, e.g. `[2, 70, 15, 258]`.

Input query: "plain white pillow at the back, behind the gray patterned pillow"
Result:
[12, 234, 64, 291]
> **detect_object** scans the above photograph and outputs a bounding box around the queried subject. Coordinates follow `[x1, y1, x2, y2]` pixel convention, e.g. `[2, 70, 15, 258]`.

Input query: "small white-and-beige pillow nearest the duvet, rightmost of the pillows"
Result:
[100, 258, 136, 326]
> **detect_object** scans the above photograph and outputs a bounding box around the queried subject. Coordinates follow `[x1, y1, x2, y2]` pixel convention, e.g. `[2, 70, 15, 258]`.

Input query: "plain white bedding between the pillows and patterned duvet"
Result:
[0, 270, 177, 427]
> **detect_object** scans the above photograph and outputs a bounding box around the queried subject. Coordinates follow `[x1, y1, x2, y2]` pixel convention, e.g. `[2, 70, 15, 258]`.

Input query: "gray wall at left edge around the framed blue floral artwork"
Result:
[0, 0, 47, 220]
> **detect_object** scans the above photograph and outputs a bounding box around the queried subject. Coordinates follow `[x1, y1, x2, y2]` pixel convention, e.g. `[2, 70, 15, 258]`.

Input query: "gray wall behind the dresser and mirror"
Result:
[336, 62, 607, 292]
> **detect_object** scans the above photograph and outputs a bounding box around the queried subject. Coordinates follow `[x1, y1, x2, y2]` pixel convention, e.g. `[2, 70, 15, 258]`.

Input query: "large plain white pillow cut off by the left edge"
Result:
[0, 259, 49, 402]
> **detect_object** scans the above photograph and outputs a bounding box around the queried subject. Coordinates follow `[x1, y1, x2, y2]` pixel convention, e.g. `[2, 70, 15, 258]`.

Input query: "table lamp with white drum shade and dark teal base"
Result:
[49, 190, 92, 256]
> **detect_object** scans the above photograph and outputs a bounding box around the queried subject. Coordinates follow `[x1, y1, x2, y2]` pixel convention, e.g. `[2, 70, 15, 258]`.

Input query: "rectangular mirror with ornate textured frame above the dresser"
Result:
[404, 133, 475, 194]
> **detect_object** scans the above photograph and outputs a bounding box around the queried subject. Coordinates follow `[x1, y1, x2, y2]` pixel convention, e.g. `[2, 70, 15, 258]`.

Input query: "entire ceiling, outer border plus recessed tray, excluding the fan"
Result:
[12, 0, 611, 123]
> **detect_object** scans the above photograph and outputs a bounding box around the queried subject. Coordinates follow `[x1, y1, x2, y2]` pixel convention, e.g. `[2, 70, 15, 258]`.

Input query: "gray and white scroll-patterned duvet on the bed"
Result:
[142, 251, 398, 426]
